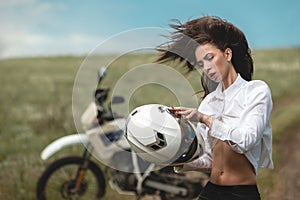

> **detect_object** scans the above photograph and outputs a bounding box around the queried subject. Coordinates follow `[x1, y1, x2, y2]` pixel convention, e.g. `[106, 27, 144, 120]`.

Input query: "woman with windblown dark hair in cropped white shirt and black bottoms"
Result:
[158, 16, 273, 200]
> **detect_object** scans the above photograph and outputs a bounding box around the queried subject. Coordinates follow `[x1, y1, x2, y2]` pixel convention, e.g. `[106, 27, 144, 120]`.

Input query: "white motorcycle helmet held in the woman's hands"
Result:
[125, 104, 204, 165]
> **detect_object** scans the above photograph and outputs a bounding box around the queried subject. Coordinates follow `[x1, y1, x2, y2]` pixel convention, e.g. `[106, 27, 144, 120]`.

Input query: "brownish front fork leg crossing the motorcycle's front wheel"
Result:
[74, 145, 91, 192]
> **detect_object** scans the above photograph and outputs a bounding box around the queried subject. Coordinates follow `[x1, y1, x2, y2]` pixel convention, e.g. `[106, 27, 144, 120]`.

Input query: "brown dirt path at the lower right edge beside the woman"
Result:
[271, 127, 300, 200]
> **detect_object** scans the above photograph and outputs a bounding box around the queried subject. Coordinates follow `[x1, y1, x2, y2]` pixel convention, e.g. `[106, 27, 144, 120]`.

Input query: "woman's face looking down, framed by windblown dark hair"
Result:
[195, 43, 232, 82]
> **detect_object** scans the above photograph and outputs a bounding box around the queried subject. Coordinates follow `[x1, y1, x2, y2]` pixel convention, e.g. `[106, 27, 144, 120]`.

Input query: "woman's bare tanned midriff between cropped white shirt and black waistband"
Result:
[210, 140, 256, 185]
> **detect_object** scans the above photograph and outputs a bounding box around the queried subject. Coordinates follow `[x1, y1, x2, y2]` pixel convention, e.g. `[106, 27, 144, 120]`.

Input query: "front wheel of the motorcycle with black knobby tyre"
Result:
[37, 157, 106, 200]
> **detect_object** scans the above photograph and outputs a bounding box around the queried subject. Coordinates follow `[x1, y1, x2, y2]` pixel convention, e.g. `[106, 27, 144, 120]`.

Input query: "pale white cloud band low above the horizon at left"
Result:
[0, 31, 100, 58]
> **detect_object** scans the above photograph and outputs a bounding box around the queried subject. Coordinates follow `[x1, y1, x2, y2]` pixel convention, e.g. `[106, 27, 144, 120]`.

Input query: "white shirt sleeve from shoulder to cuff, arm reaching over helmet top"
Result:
[209, 82, 272, 154]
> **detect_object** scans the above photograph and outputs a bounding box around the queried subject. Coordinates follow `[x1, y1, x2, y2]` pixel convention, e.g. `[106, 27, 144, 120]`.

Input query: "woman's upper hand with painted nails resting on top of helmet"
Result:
[171, 106, 213, 128]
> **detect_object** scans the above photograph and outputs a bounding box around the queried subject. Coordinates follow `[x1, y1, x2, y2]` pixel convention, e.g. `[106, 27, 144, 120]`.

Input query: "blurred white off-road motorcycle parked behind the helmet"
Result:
[36, 68, 207, 200]
